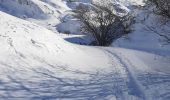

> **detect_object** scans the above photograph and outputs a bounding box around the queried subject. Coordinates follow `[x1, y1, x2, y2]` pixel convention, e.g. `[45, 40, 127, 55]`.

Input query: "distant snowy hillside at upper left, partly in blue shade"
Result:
[0, 0, 69, 32]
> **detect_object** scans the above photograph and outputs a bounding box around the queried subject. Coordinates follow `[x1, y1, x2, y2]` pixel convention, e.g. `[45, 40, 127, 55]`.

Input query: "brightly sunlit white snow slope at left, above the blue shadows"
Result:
[0, 12, 115, 74]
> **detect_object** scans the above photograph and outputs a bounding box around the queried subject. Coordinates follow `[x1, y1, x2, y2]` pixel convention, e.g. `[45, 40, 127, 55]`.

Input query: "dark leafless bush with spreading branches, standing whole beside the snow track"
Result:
[74, 0, 133, 46]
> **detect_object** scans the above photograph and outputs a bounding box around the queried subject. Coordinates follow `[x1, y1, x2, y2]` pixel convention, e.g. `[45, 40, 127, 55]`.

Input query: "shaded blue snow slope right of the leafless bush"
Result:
[113, 0, 170, 56]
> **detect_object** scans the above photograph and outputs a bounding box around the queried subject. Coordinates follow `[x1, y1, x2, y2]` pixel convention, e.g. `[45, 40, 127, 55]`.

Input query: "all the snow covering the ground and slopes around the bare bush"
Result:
[0, 0, 170, 100]
